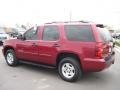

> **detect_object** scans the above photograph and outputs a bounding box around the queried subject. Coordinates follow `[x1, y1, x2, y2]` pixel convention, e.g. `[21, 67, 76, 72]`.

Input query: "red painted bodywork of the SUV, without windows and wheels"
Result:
[3, 23, 115, 72]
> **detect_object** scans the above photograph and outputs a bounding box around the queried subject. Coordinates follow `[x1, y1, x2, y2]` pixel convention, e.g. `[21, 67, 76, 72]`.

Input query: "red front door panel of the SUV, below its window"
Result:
[16, 40, 39, 61]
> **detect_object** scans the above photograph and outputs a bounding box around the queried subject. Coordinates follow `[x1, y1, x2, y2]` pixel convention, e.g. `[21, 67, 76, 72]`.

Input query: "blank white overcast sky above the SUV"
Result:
[0, 0, 120, 28]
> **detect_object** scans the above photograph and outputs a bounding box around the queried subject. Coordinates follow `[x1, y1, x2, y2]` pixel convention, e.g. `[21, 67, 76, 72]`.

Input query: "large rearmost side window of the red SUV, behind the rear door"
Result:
[65, 25, 95, 42]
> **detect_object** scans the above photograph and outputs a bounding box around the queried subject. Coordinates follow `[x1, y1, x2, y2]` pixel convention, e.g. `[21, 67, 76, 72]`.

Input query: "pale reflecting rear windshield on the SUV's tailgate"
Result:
[98, 27, 112, 41]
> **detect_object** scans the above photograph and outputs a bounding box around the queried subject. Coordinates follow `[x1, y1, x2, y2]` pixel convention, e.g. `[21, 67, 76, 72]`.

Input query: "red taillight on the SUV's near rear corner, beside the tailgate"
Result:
[95, 43, 103, 59]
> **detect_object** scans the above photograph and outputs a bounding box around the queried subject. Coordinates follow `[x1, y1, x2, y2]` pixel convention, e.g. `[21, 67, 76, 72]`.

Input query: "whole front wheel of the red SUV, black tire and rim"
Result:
[5, 49, 19, 66]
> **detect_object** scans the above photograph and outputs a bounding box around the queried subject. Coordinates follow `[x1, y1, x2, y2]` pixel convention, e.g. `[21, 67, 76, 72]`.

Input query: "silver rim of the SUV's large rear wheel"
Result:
[62, 63, 75, 79]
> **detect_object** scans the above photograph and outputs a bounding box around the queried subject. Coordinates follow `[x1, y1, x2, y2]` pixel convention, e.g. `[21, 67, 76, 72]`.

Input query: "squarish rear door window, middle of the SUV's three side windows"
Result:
[43, 26, 59, 41]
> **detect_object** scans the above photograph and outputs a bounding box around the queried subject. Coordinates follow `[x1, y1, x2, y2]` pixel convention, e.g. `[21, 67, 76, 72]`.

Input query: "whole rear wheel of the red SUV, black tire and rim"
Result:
[58, 57, 82, 82]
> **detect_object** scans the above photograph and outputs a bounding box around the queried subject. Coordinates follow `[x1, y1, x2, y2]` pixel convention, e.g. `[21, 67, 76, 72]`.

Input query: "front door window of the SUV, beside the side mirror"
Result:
[24, 27, 38, 40]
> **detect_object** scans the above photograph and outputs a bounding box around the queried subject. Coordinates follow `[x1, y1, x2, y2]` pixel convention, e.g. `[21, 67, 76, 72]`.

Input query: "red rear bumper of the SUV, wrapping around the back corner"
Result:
[82, 54, 115, 72]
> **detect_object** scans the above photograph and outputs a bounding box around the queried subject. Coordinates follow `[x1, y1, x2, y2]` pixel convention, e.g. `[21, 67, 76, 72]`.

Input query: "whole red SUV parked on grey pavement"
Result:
[3, 22, 115, 82]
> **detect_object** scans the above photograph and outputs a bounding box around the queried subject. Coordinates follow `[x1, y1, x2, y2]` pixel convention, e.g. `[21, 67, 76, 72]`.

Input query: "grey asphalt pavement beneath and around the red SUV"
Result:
[0, 47, 120, 90]
